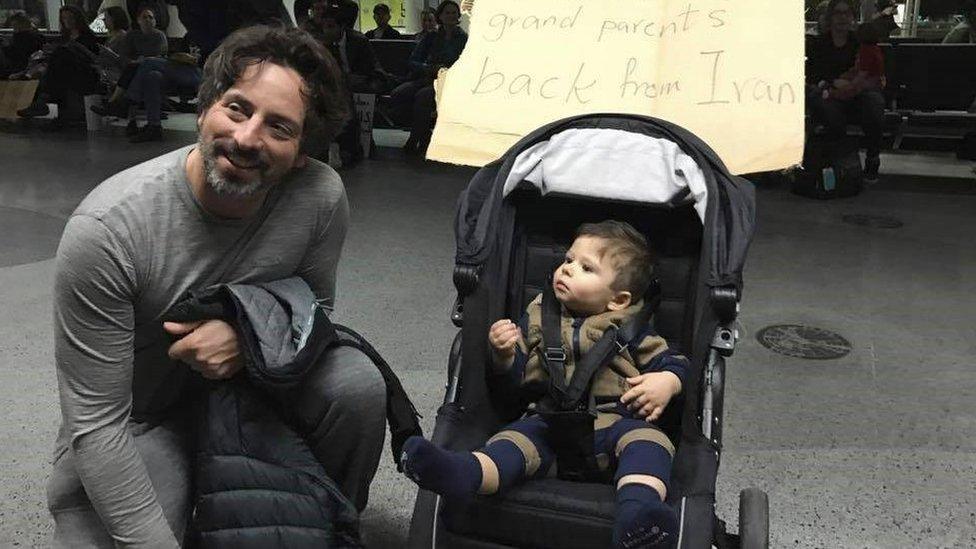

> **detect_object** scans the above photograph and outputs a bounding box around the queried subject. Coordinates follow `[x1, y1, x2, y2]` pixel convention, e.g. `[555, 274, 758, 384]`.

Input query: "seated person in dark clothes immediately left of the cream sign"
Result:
[390, 0, 468, 156]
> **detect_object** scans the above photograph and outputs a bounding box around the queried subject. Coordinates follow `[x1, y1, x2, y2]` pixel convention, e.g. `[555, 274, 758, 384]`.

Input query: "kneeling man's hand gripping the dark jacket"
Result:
[163, 320, 244, 379]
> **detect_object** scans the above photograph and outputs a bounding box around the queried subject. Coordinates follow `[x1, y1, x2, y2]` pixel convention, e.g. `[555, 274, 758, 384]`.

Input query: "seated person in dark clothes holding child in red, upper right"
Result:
[807, 0, 885, 182]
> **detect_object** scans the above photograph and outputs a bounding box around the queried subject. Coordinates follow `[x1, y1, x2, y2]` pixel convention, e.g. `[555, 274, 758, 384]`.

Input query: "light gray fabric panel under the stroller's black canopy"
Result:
[503, 128, 708, 221]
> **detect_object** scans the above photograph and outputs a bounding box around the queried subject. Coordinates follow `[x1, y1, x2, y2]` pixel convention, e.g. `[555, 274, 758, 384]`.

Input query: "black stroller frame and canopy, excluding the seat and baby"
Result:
[409, 114, 768, 549]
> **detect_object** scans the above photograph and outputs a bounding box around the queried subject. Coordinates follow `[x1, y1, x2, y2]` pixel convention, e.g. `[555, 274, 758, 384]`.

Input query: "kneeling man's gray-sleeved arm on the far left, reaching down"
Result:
[54, 215, 179, 547]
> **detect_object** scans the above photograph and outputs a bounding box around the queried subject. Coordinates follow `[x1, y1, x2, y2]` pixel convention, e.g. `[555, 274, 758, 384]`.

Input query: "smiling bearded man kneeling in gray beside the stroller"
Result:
[48, 27, 385, 547]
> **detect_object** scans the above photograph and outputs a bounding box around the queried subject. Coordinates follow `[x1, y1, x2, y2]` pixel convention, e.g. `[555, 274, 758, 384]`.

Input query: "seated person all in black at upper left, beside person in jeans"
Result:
[17, 5, 99, 127]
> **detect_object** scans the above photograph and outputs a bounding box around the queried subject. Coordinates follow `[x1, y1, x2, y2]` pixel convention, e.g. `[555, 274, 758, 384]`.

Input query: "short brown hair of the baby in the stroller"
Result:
[576, 219, 654, 302]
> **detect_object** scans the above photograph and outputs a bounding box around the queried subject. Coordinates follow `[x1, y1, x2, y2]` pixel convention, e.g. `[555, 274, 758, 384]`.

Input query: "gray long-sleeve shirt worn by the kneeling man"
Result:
[54, 147, 349, 547]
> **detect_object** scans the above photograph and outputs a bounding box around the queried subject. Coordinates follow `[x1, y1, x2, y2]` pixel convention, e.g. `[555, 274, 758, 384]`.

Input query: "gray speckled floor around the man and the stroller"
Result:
[0, 125, 976, 548]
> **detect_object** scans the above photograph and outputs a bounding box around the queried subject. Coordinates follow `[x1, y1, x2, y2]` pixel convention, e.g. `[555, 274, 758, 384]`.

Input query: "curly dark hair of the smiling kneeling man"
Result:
[197, 25, 350, 148]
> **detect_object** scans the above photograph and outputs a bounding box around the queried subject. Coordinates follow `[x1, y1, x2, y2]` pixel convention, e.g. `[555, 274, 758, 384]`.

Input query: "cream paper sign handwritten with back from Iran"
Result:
[427, 0, 804, 173]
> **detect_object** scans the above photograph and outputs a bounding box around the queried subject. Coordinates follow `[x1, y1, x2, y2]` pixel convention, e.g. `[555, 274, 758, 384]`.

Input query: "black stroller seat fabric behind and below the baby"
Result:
[442, 191, 701, 547]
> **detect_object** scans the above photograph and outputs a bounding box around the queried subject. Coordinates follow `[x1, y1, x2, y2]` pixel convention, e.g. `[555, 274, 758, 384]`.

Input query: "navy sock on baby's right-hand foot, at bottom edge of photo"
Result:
[613, 483, 679, 549]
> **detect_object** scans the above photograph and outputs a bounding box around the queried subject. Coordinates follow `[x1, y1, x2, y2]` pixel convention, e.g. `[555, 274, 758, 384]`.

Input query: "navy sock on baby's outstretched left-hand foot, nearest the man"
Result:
[400, 436, 481, 498]
